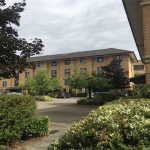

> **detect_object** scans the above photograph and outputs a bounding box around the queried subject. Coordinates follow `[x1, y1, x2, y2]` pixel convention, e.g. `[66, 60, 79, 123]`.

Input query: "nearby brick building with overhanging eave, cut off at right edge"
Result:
[123, 0, 150, 84]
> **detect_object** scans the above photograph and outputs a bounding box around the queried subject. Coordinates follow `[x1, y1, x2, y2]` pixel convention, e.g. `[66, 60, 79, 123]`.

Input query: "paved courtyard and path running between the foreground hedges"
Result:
[12, 98, 97, 150]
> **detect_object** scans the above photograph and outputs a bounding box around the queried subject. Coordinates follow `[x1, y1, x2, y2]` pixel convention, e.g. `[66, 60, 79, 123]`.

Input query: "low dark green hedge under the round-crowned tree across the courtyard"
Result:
[77, 93, 118, 105]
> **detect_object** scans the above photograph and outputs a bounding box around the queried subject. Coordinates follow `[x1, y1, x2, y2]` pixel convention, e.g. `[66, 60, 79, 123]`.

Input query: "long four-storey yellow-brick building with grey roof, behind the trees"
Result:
[0, 48, 137, 92]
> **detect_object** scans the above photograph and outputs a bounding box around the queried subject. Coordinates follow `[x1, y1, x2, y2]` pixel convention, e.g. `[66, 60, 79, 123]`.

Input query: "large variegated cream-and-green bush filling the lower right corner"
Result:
[49, 99, 150, 150]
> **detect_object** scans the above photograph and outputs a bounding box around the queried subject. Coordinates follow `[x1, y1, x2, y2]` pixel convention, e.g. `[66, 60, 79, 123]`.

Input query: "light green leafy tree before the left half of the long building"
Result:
[21, 68, 60, 95]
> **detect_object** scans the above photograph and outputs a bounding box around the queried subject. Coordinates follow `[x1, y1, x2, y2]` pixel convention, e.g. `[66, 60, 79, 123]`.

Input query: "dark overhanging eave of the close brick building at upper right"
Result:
[122, 0, 144, 57]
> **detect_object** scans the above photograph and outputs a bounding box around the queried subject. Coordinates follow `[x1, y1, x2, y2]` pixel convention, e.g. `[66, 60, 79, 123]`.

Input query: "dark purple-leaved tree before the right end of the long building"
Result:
[103, 59, 129, 89]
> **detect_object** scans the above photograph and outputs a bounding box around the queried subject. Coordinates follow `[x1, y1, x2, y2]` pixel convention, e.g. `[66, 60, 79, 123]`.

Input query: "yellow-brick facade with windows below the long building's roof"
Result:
[0, 50, 136, 92]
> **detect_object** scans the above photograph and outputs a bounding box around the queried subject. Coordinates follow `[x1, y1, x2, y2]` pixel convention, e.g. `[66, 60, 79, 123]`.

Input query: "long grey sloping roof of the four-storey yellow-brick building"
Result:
[27, 48, 137, 62]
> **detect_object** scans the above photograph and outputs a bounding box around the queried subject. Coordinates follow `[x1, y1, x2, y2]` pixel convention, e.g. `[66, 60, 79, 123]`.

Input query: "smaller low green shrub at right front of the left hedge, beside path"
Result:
[22, 117, 50, 139]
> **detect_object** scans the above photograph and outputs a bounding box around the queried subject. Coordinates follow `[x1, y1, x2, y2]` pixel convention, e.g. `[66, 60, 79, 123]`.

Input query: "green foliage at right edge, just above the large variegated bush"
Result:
[134, 84, 150, 98]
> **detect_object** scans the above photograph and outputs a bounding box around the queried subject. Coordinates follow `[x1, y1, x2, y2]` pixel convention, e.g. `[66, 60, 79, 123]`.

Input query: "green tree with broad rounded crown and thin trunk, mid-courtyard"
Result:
[69, 73, 110, 98]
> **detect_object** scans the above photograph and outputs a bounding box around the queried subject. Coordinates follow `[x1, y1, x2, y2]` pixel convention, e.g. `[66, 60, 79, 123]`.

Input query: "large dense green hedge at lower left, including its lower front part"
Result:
[0, 95, 50, 149]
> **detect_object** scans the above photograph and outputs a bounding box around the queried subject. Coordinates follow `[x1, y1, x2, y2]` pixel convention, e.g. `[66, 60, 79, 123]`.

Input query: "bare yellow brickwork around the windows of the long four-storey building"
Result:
[0, 54, 134, 92]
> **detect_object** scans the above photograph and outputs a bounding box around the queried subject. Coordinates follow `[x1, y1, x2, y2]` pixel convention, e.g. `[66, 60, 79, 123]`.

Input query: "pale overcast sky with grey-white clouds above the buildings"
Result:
[6, 0, 138, 56]
